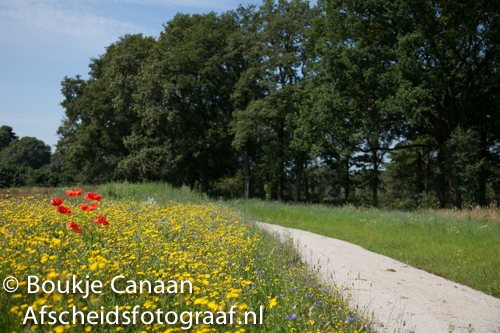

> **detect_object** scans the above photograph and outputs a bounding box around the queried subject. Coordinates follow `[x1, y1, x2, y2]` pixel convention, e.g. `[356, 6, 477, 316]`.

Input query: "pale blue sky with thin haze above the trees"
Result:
[0, 0, 315, 151]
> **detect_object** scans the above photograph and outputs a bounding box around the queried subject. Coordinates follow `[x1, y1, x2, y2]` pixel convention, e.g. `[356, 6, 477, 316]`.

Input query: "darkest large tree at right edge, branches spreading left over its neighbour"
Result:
[325, 0, 500, 207]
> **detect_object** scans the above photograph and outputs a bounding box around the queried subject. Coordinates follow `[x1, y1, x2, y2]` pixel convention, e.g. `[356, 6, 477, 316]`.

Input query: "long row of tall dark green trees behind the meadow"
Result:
[44, 0, 500, 208]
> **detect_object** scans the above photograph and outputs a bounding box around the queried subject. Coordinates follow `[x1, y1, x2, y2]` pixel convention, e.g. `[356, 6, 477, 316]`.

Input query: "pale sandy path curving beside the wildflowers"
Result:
[259, 223, 500, 333]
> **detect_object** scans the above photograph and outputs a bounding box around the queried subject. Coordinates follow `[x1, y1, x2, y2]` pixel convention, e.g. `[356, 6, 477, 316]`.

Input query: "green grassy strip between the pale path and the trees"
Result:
[227, 200, 500, 297]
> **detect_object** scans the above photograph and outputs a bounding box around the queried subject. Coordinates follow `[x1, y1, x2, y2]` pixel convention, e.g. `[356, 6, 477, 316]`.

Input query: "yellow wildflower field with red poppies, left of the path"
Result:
[0, 190, 370, 333]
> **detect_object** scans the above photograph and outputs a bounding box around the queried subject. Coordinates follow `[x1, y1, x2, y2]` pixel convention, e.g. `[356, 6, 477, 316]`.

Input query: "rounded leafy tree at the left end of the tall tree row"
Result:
[58, 35, 155, 182]
